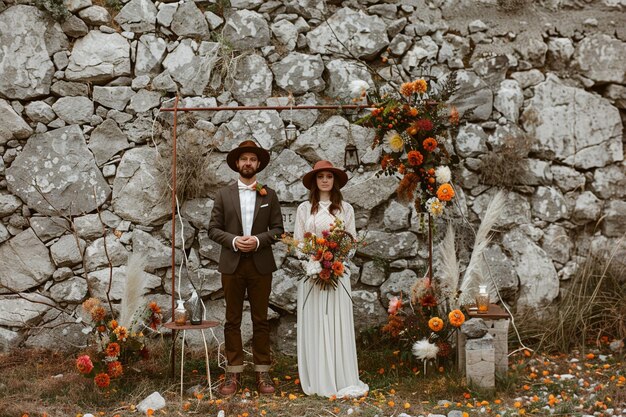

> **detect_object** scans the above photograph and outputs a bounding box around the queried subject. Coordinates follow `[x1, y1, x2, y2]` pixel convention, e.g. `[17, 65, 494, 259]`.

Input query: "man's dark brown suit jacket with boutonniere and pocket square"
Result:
[209, 182, 284, 274]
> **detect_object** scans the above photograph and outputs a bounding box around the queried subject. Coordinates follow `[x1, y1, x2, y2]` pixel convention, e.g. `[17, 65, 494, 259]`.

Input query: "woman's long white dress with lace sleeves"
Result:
[294, 201, 369, 398]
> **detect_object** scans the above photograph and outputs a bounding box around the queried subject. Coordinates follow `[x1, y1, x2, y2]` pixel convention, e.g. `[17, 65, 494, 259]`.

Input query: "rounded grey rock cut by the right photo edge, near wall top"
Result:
[573, 33, 626, 84]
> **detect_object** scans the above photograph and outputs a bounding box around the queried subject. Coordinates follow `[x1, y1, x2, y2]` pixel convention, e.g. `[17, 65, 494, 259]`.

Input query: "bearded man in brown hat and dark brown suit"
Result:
[209, 140, 283, 396]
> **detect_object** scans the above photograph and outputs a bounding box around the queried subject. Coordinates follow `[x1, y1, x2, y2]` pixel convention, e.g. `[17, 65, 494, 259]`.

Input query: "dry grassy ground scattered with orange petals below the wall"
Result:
[0, 336, 626, 417]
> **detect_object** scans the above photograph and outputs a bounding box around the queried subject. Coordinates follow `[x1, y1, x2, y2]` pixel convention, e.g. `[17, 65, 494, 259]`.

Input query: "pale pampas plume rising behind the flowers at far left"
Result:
[119, 253, 147, 331]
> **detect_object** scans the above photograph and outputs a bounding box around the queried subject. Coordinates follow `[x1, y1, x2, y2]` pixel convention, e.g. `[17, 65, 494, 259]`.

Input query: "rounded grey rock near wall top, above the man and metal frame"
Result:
[222, 10, 270, 49]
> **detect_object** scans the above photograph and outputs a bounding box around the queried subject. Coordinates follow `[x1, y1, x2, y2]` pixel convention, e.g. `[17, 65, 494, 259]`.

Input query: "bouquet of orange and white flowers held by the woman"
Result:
[283, 219, 363, 290]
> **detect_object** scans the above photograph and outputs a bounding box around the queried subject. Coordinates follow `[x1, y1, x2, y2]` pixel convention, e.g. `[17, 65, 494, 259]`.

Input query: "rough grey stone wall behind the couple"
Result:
[0, 0, 626, 353]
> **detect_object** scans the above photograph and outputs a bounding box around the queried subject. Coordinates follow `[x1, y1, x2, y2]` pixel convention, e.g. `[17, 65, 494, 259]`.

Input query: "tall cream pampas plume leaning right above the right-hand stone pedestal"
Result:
[459, 190, 506, 304]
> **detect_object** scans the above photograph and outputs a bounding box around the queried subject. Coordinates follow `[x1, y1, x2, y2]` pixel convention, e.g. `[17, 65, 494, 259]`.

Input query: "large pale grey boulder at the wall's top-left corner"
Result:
[0, 4, 68, 100]
